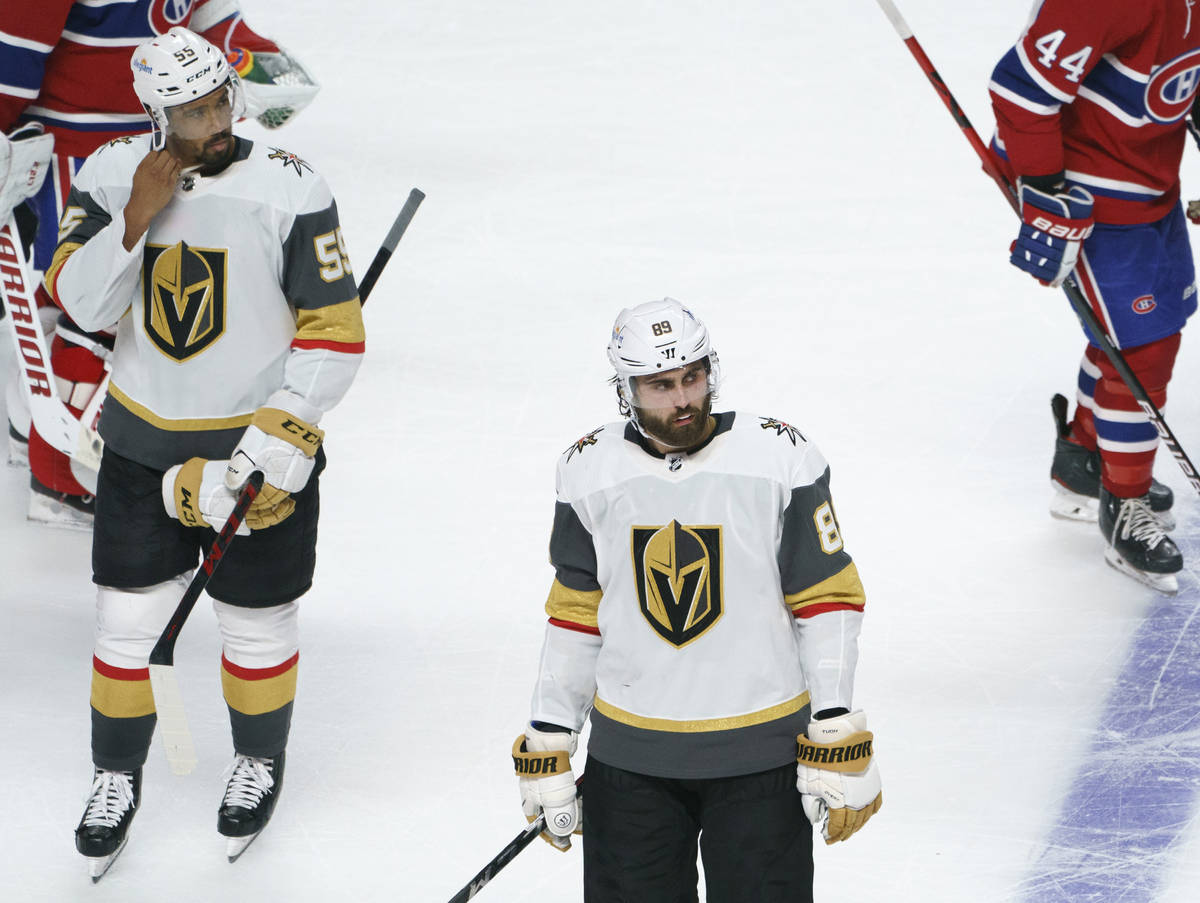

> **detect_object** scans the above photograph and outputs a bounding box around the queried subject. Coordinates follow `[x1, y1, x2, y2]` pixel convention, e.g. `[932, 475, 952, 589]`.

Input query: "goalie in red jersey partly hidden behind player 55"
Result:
[0, 0, 317, 528]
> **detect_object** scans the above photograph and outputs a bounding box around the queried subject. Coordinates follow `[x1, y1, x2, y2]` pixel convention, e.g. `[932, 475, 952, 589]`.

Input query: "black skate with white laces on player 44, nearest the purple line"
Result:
[1099, 486, 1183, 593]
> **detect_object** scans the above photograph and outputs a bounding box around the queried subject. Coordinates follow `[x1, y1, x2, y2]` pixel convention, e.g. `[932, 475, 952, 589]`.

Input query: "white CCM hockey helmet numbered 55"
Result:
[130, 25, 246, 150]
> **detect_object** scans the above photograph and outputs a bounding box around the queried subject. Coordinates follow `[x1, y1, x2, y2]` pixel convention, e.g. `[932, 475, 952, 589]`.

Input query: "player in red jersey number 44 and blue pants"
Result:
[990, 0, 1200, 592]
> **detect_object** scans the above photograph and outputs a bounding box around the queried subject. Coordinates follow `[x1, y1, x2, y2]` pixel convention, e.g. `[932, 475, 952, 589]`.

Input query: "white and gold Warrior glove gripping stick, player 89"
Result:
[512, 724, 583, 850]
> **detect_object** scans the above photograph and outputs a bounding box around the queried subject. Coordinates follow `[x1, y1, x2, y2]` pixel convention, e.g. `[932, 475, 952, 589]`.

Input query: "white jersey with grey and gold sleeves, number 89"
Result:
[532, 413, 865, 778]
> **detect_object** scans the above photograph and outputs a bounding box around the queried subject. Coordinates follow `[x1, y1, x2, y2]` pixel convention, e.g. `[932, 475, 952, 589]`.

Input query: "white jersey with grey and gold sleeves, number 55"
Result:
[46, 136, 365, 470]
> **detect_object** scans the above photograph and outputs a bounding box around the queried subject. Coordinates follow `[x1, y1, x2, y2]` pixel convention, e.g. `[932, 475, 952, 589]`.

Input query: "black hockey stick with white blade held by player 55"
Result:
[150, 189, 425, 775]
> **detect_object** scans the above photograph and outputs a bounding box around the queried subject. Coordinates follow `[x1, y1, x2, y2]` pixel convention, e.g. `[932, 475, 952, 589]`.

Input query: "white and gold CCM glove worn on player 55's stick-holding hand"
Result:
[226, 391, 325, 511]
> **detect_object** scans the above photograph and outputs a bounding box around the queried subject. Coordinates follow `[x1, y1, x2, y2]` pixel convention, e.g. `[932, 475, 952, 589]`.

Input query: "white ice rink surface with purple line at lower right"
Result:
[0, 0, 1200, 903]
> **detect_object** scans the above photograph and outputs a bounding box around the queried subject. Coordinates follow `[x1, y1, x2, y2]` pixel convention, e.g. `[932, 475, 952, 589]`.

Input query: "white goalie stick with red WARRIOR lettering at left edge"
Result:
[0, 213, 79, 456]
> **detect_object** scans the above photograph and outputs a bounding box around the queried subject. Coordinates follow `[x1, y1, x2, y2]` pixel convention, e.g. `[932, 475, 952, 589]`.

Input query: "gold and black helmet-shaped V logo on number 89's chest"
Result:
[630, 520, 725, 646]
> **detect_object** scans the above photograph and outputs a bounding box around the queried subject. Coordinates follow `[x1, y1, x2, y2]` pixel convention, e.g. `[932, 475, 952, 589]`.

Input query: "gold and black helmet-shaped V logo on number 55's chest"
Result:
[142, 241, 228, 361]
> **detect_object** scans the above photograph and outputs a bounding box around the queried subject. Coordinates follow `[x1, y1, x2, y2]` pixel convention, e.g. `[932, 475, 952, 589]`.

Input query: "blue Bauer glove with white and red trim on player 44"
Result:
[1008, 183, 1094, 288]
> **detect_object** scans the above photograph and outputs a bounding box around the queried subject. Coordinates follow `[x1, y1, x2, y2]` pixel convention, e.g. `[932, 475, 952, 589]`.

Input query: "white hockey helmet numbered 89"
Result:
[608, 298, 721, 420]
